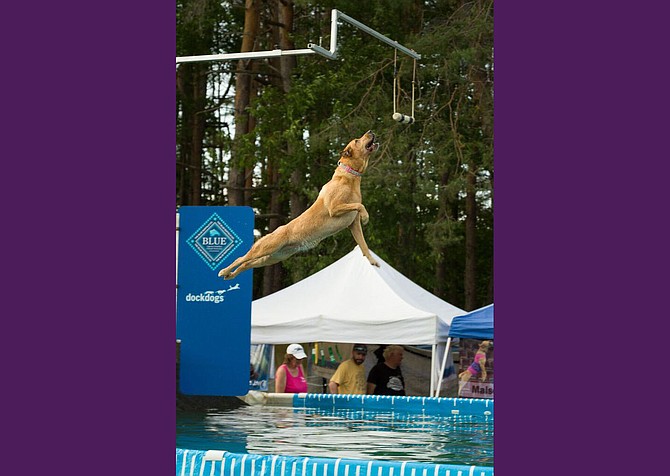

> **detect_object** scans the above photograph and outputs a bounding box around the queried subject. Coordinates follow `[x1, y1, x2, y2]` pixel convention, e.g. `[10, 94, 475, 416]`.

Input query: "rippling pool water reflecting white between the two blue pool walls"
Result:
[176, 405, 493, 466]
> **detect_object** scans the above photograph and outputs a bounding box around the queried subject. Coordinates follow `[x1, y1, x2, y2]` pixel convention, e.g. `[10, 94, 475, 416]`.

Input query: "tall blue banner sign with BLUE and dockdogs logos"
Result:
[177, 206, 254, 396]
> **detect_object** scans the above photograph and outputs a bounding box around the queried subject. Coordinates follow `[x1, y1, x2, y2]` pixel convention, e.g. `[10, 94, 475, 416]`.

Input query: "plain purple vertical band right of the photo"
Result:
[495, 1, 670, 476]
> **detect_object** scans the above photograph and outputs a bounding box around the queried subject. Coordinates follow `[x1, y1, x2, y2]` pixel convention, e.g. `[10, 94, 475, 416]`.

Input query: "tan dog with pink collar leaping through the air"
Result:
[219, 131, 379, 279]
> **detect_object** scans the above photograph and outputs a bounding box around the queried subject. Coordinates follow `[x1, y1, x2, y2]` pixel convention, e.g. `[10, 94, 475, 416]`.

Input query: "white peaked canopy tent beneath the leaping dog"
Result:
[251, 246, 465, 395]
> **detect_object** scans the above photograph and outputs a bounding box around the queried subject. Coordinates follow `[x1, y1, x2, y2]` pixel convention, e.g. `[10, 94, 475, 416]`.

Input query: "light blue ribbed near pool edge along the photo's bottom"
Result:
[176, 448, 493, 476]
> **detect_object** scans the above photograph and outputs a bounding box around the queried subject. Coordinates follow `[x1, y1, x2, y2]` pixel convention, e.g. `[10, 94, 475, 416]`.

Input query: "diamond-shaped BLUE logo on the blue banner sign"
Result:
[186, 213, 242, 270]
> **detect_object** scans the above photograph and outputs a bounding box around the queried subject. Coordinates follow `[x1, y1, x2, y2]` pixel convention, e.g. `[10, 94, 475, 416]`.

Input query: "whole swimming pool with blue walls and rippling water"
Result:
[177, 394, 493, 476]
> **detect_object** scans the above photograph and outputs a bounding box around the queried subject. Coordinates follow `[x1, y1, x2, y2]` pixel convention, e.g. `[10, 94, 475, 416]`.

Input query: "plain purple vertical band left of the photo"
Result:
[0, 1, 176, 476]
